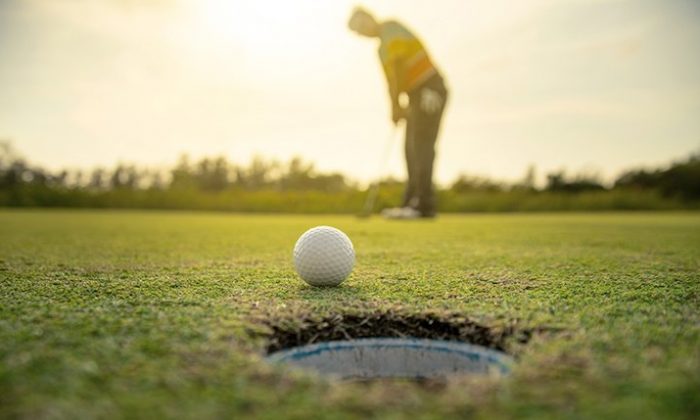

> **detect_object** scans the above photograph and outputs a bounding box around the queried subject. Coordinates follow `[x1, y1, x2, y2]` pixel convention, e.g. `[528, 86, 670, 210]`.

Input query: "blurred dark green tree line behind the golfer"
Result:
[0, 142, 700, 212]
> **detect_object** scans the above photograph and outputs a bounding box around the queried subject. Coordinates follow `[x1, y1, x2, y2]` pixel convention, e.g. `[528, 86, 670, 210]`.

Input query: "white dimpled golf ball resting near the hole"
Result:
[294, 226, 355, 286]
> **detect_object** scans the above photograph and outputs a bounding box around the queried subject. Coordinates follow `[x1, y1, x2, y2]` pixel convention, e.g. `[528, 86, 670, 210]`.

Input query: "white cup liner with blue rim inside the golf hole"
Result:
[268, 338, 512, 380]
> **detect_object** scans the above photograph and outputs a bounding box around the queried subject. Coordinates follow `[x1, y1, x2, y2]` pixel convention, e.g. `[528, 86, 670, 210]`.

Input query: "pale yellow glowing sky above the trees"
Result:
[0, 0, 700, 183]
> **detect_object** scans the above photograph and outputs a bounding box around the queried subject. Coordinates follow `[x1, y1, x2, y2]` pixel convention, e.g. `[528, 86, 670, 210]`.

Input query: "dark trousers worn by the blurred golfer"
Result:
[403, 75, 447, 217]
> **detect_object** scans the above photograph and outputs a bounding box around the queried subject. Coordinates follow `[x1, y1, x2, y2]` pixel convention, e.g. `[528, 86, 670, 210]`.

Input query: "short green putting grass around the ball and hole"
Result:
[0, 210, 700, 419]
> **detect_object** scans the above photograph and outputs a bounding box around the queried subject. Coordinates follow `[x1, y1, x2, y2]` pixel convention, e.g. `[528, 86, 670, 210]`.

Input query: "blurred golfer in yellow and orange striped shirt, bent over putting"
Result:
[348, 8, 447, 219]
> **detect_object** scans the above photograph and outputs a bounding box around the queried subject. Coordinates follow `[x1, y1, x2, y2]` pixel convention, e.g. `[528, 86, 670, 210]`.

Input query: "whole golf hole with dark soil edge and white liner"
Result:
[266, 311, 532, 381]
